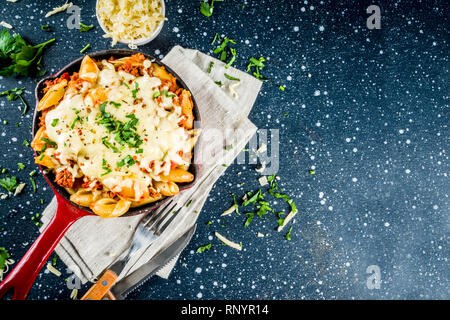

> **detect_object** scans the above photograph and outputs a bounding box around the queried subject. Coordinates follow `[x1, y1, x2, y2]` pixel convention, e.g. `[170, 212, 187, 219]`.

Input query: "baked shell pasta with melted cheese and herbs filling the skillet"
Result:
[31, 54, 198, 217]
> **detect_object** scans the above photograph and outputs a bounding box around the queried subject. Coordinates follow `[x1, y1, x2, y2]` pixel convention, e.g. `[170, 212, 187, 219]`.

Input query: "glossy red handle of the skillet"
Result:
[0, 194, 86, 300]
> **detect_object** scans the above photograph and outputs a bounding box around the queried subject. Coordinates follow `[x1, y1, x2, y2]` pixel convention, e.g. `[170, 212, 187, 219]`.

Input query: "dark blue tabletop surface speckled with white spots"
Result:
[0, 0, 450, 299]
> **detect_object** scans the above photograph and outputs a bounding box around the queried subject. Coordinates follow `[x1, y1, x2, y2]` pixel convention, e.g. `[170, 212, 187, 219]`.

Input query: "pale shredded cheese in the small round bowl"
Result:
[97, 0, 164, 46]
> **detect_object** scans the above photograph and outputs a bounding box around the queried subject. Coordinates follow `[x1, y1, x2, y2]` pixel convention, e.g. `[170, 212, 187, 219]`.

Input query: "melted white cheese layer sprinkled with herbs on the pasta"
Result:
[45, 60, 192, 200]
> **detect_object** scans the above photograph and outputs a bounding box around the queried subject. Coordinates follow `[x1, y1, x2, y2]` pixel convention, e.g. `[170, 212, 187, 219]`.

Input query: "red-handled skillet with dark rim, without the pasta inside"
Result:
[0, 49, 200, 300]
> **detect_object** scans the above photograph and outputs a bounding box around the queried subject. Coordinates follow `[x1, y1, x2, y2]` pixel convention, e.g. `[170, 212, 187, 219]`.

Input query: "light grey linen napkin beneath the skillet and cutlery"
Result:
[41, 46, 261, 283]
